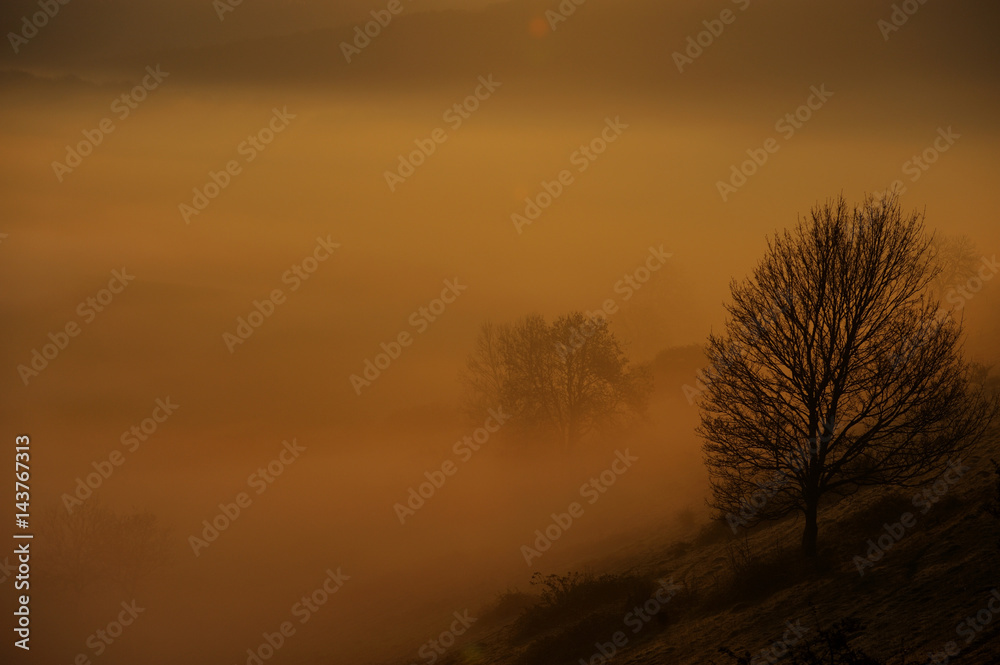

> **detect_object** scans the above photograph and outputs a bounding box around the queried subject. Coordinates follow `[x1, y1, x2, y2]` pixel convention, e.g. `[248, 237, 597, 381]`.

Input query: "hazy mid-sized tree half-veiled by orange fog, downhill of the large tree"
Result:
[463, 312, 651, 450]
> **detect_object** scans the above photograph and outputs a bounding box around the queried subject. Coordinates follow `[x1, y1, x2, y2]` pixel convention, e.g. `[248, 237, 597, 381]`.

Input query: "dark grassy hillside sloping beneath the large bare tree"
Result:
[426, 420, 1000, 665]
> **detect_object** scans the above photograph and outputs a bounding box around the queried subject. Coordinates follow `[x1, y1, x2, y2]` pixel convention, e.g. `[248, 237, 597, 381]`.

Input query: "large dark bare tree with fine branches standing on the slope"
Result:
[699, 197, 997, 556]
